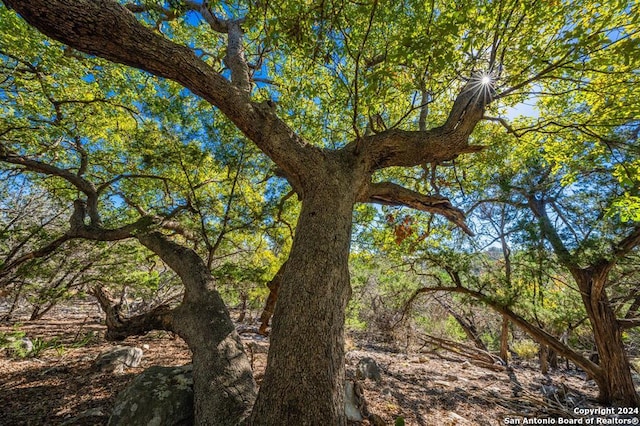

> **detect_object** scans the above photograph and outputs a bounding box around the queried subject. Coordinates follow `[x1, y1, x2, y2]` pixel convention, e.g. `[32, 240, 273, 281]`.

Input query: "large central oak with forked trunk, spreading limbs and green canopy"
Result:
[4, 0, 640, 425]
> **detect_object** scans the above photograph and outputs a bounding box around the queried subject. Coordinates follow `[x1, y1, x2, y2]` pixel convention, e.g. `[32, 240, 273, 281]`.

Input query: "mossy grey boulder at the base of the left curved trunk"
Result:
[109, 365, 193, 426]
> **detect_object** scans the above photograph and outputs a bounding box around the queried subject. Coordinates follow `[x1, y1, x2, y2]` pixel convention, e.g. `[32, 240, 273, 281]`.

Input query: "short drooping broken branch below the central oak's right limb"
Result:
[358, 182, 473, 235]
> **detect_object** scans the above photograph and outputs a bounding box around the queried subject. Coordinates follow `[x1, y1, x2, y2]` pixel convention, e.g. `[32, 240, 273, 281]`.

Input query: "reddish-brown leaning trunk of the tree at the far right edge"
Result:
[574, 268, 640, 407]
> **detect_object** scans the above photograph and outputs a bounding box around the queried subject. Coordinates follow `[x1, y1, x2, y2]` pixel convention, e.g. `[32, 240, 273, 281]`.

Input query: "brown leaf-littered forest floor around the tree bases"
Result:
[0, 303, 632, 426]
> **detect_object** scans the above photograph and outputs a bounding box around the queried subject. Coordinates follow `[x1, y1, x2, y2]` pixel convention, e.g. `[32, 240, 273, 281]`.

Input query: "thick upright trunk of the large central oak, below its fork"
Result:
[251, 171, 355, 426]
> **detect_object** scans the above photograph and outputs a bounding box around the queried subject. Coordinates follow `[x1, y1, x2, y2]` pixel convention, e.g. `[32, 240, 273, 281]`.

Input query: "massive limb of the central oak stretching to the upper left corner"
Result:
[3, 0, 322, 187]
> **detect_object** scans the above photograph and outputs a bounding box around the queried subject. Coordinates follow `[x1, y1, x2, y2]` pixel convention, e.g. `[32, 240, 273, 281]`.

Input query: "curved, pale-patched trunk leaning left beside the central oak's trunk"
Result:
[137, 232, 256, 426]
